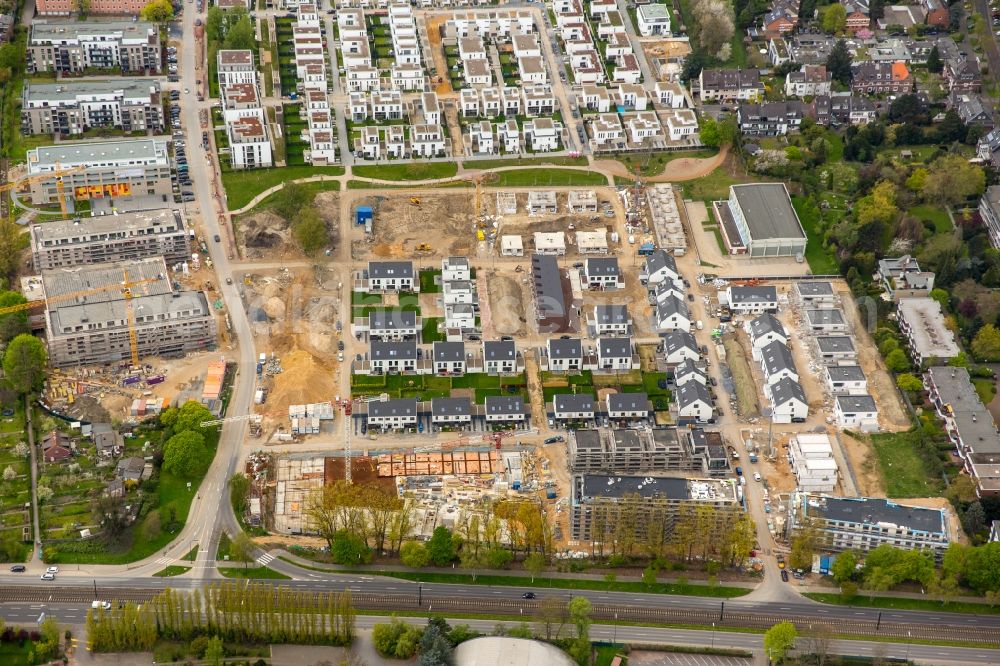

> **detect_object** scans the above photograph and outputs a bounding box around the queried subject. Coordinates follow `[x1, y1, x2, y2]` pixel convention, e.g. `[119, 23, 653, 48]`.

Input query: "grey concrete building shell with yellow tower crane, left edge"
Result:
[38, 257, 217, 367]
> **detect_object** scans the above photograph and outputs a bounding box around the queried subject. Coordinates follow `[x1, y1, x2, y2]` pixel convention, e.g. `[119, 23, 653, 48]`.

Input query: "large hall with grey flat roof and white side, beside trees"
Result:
[714, 183, 806, 258]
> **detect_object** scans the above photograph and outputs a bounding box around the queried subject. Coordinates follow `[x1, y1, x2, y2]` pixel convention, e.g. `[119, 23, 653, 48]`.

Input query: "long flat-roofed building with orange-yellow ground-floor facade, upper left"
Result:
[27, 139, 173, 204]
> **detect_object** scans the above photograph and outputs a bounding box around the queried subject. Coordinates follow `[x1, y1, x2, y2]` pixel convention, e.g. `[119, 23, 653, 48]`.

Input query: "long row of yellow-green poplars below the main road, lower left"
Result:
[87, 581, 355, 652]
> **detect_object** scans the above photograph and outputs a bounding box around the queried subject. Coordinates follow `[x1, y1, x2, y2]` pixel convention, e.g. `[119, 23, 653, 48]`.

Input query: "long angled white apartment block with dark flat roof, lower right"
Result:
[787, 492, 951, 557]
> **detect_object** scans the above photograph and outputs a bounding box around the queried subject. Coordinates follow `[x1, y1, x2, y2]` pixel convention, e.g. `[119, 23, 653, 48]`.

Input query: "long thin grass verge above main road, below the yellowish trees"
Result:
[356, 570, 750, 599]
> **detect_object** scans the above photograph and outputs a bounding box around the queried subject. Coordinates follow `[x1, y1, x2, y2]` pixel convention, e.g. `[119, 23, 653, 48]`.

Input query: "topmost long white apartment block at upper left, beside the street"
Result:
[25, 20, 163, 74]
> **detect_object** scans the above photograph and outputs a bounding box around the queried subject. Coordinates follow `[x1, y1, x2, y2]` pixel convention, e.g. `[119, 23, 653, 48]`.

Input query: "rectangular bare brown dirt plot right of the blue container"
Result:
[351, 193, 476, 261]
